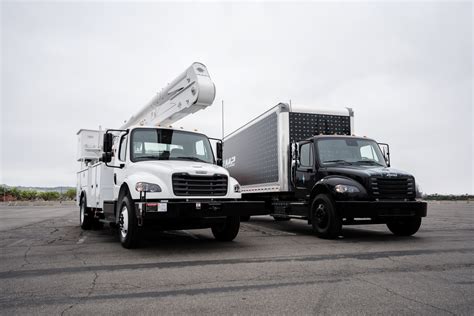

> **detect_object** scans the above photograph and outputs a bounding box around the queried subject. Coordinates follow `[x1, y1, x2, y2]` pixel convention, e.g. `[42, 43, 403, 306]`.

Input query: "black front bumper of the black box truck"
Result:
[336, 201, 428, 219]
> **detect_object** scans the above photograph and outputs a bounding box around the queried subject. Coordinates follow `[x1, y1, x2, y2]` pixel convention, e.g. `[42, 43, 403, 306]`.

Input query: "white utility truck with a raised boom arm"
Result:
[77, 63, 265, 248]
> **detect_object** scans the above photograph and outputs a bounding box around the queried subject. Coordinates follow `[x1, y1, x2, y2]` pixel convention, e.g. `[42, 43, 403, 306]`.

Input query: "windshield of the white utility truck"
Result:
[130, 128, 214, 163]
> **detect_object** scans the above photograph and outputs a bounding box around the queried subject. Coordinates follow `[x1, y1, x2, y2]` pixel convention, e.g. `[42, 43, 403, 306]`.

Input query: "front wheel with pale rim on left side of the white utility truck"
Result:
[117, 195, 139, 249]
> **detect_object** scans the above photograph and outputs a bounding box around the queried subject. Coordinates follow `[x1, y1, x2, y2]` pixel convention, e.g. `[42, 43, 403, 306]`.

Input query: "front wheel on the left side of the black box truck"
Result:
[310, 194, 342, 239]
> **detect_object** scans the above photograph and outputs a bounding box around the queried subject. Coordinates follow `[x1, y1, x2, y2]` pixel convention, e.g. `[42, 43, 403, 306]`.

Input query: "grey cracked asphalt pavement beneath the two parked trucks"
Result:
[0, 202, 474, 315]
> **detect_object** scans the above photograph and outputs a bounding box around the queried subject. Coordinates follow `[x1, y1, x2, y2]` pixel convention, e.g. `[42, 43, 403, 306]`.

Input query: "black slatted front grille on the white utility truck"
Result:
[172, 173, 227, 196]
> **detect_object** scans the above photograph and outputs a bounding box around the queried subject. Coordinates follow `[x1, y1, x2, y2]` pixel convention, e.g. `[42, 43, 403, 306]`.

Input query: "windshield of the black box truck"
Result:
[317, 138, 386, 167]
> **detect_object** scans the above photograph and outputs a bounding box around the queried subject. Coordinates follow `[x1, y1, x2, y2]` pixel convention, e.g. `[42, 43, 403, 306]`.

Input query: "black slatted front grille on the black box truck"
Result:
[370, 177, 416, 199]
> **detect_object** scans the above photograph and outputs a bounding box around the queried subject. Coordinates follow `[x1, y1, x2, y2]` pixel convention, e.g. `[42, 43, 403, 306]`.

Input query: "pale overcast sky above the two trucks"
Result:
[0, 2, 474, 194]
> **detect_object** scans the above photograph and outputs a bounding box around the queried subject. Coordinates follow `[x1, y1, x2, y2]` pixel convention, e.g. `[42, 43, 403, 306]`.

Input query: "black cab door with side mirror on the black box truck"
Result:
[294, 142, 316, 200]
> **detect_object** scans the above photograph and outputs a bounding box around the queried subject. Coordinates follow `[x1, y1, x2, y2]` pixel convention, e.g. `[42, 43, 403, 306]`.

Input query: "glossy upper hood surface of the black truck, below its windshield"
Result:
[321, 165, 412, 183]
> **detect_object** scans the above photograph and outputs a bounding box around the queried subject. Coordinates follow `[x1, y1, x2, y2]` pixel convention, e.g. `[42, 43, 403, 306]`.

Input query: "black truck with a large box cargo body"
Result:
[223, 103, 427, 238]
